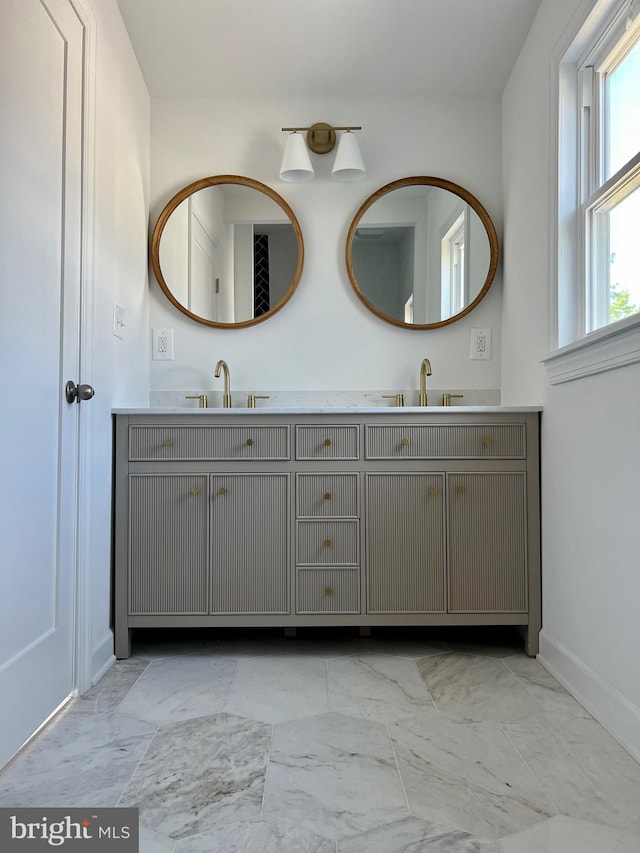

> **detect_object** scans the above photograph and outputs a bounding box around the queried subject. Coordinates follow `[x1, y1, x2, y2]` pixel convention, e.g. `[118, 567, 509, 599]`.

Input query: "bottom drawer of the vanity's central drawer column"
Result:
[296, 568, 360, 613]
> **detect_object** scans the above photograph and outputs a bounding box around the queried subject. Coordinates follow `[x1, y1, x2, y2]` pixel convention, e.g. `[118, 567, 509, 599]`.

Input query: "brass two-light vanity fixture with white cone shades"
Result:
[280, 122, 367, 181]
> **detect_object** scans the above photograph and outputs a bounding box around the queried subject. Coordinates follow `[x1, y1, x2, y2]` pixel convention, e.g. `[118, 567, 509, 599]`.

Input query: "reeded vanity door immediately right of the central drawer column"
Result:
[366, 473, 446, 613]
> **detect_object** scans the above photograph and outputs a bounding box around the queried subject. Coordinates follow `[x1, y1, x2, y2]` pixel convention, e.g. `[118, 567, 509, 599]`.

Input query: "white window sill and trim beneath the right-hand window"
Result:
[542, 314, 640, 385]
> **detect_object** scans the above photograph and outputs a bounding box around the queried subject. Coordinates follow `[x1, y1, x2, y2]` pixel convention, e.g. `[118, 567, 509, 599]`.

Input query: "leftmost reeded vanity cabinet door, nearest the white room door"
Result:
[129, 474, 208, 615]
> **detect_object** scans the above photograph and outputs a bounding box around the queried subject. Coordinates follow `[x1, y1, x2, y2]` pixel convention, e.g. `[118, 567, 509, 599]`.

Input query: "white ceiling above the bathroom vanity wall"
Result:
[118, 0, 540, 97]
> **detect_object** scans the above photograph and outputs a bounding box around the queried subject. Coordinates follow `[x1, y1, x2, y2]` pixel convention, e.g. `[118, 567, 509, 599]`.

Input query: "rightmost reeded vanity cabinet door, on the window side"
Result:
[447, 472, 527, 613]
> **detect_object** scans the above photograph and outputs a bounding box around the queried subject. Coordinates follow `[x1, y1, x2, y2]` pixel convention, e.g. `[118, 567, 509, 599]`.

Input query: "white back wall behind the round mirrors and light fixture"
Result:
[151, 97, 502, 404]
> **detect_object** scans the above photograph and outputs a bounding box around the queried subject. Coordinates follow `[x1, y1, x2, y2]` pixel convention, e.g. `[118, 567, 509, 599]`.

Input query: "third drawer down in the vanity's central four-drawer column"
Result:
[296, 520, 359, 566]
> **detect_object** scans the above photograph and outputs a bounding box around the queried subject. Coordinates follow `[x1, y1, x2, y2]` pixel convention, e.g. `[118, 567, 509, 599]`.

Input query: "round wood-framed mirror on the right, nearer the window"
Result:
[346, 176, 498, 329]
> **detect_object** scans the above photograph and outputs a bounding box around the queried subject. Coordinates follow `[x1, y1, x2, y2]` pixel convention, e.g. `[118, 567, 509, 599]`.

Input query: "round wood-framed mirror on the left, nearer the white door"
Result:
[151, 175, 304, 328]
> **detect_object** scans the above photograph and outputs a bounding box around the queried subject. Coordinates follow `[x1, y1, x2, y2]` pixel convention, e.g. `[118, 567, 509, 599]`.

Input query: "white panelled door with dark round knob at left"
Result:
[0, 0, 87, 765]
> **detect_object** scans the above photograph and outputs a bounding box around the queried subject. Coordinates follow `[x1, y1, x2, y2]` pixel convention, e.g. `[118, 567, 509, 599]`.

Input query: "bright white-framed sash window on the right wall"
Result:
[580, 26, 640, 332]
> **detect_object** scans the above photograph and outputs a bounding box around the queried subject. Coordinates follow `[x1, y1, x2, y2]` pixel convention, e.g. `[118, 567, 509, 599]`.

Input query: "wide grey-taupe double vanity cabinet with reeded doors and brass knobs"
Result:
[114, 407, 540, 658]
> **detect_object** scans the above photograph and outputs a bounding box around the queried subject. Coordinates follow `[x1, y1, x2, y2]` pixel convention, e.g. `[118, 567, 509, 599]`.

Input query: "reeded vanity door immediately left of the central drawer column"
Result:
[210, 474, 291, 614]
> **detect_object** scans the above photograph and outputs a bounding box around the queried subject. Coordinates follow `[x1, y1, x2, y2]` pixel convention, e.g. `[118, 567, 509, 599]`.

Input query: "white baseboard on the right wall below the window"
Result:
[538, 628, 640, 762]
